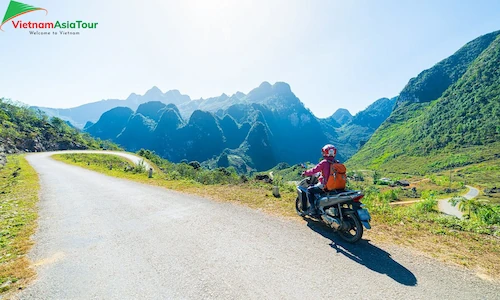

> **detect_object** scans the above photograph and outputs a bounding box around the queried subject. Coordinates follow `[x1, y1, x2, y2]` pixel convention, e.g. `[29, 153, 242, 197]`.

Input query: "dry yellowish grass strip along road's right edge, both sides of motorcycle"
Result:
[54, 155, 500, 280]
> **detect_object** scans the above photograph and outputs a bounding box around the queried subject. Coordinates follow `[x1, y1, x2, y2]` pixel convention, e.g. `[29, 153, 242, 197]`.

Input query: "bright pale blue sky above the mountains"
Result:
[0, 0, 500, 117]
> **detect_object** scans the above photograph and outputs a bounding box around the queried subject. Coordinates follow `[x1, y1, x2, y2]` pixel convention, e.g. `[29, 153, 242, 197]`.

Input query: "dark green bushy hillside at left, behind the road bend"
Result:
[0, 99, 117, 160]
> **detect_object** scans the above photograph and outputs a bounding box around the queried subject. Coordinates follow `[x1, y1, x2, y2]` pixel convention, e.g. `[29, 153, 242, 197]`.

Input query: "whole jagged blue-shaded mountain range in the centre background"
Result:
[86, 82, 341, 171]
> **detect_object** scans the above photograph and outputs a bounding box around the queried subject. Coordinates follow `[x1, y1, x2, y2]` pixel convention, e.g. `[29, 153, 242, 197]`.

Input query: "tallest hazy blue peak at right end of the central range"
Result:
[220, 82, 332, 164]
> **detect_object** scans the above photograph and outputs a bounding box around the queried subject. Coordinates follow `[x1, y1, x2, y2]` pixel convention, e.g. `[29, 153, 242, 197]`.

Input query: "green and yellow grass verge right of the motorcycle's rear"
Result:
[362, 187, 500, 280]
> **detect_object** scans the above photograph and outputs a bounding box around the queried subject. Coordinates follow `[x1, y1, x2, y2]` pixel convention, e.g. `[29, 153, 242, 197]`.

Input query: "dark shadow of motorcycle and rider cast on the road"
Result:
[304, 218, 417, 286]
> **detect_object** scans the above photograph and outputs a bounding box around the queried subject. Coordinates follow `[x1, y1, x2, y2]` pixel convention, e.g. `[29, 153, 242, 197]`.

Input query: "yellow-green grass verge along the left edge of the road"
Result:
[0, 155, 39, 293]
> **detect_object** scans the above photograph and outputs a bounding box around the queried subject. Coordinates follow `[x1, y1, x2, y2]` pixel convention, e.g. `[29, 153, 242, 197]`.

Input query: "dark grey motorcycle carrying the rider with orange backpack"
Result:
[295, 176, 371, 243]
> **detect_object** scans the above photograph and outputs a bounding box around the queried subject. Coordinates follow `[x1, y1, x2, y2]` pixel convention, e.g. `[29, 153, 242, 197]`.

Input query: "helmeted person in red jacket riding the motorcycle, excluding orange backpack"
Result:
[302, 144, 337, 215]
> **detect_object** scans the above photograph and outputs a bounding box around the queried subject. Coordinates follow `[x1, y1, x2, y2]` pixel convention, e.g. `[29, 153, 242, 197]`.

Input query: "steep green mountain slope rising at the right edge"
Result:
[349, 31, 500, 173]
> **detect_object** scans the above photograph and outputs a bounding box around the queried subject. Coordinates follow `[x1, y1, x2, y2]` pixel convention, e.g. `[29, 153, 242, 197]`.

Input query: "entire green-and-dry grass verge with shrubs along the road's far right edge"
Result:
[53, 154, 500, 280]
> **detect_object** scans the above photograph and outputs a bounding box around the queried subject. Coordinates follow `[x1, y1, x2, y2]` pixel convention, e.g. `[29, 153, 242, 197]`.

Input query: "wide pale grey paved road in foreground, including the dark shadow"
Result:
[14, 153, 500, 299]
